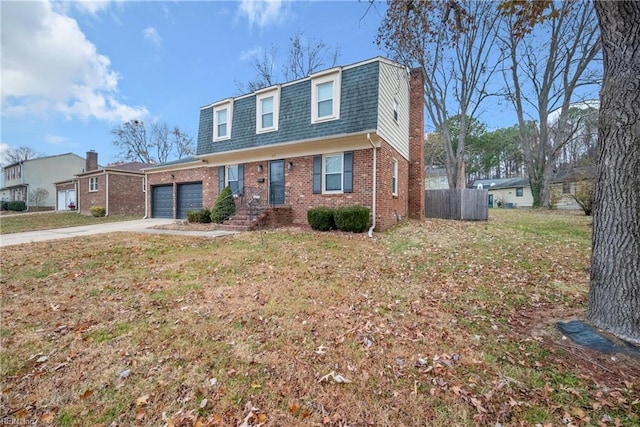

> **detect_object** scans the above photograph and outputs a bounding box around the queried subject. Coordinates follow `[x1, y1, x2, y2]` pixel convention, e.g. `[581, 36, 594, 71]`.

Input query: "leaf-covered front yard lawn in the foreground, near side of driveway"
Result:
[0, 210, 640, 426]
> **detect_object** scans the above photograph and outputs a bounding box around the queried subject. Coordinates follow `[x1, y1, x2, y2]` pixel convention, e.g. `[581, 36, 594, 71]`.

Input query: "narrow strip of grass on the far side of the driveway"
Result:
[0, 212, 140, 234]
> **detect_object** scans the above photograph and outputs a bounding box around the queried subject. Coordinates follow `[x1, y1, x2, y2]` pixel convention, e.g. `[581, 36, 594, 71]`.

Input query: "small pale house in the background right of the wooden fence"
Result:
[472, 177, 533, 208]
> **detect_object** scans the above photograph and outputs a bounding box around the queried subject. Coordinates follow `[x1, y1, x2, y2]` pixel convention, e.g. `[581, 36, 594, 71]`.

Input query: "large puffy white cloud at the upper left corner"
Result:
[1, 1, 148, 122]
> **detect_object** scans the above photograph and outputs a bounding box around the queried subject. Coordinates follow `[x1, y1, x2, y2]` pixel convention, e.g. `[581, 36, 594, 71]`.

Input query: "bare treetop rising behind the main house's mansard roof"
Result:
[236, 33, 340, 93]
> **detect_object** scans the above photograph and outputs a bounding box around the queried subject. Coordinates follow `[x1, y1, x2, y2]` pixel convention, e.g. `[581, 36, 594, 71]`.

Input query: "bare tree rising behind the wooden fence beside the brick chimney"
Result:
[377, 0, 500, 188]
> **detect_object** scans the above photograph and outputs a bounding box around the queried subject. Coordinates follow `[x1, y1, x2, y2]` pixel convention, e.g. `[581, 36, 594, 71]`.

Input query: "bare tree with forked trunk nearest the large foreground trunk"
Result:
[502, 2, 601, 207]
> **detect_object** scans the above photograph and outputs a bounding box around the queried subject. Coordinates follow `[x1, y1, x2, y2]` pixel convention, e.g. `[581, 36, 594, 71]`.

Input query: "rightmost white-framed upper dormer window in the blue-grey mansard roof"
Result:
[311, 69, 342, 123]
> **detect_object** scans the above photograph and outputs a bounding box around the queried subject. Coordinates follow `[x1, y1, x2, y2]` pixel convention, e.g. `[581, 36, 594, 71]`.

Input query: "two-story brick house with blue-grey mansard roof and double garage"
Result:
[145, 57, 424, 231]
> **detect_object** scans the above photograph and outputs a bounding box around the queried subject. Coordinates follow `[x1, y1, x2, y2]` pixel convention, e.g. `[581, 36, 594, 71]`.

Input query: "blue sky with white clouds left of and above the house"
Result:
[0, 0, 392, 164]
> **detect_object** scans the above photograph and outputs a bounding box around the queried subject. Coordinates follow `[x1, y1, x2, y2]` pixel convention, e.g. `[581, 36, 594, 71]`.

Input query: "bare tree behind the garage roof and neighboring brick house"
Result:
[111, 120, 195, 167]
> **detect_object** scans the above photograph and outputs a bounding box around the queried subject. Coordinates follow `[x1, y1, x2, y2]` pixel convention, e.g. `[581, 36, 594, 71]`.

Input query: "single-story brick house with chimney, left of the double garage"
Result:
[76, 151, 151, 216]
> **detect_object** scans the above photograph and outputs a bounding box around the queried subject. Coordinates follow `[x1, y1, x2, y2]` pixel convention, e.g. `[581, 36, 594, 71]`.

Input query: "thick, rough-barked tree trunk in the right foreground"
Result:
[587, 1, 640, 343]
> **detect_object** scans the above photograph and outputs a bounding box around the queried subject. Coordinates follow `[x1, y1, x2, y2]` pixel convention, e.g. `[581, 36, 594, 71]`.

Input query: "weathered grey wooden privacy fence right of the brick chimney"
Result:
[424, 189, 489, 221]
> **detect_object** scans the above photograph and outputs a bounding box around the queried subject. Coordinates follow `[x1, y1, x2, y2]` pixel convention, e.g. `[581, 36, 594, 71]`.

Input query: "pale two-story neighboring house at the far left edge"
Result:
[0, 153, 85, 209]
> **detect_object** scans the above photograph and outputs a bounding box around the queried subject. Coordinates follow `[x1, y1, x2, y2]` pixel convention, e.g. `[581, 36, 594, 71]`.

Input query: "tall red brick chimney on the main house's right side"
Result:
[409, 68, 425, 219]
